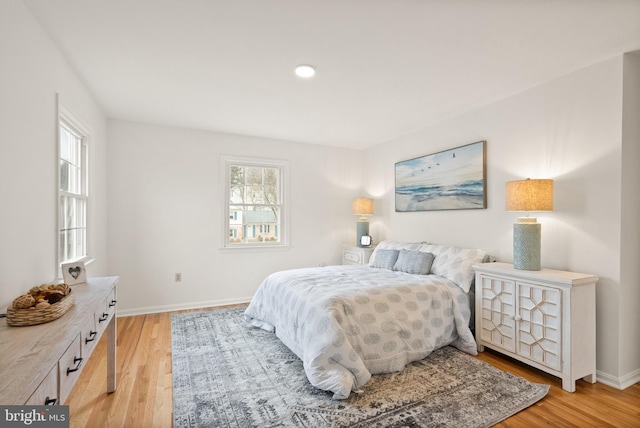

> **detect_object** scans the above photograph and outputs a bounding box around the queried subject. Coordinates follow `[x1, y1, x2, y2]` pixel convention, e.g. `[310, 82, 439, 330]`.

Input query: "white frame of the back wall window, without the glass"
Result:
[220, 156, 290, 251]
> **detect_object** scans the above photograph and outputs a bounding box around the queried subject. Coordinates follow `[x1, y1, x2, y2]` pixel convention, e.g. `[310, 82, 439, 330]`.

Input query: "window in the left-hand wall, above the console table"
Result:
[58, 113, 89, 264]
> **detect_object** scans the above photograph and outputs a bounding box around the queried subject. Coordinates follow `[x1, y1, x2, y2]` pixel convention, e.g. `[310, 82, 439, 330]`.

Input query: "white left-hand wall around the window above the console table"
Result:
[0, 0, 107, 306]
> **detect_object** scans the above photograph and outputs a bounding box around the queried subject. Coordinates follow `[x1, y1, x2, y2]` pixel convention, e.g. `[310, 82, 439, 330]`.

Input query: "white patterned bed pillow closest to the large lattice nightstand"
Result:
[420, 245, 486, 293]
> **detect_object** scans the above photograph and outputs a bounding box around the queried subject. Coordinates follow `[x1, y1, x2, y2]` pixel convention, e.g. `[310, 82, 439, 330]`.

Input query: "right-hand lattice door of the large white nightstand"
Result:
[518, 283, 562, 370]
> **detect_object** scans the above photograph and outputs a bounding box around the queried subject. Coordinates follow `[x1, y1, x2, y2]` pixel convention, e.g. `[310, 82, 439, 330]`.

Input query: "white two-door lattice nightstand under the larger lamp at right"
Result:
[474, 263, 598, 392]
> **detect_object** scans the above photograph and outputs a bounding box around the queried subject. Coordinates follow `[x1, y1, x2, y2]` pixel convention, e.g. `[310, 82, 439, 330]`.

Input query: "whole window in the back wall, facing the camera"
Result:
[222, 158, 288, 248]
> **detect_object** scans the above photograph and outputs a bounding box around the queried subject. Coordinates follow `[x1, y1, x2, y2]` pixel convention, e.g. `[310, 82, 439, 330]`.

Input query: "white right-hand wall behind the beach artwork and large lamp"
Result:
[365, 56, 640, 384]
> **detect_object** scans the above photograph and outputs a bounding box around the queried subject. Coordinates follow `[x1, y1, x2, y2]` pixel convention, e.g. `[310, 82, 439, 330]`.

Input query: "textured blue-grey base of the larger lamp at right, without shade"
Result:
[513, 217, 542, 270]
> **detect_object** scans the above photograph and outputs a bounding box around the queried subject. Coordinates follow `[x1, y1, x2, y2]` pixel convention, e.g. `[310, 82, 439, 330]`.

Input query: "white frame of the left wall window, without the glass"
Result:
[56, 104, 93, 272]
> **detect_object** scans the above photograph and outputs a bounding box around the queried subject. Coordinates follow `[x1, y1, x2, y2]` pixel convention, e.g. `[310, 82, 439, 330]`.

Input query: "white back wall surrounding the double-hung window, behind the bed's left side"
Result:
[108, 121, 362, 314]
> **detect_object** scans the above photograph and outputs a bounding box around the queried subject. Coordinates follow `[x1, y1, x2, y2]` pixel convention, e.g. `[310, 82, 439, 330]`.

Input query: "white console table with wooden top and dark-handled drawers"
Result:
[0, 276, 119, 405]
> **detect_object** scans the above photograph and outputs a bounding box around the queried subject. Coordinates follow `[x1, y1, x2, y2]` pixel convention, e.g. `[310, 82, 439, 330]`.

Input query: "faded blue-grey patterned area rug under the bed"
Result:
[171, 307, 549, 428]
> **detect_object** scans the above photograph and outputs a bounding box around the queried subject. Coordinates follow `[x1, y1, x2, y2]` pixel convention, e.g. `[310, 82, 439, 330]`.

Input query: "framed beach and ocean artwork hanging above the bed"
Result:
[395, 141, 487, 212]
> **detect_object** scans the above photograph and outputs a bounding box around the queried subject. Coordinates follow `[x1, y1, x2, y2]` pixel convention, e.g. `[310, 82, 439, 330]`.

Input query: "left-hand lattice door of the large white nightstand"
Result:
[480, 276, 516, 352]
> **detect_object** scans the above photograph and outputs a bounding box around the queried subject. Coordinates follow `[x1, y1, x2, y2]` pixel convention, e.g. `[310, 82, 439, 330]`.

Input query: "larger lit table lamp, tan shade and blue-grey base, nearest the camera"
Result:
[506, 178, 553, 270]
